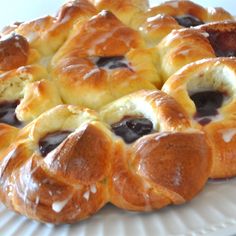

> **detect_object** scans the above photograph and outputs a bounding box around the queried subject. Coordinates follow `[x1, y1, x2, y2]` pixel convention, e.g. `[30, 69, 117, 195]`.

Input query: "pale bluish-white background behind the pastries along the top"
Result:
[0, 0, 236, 28]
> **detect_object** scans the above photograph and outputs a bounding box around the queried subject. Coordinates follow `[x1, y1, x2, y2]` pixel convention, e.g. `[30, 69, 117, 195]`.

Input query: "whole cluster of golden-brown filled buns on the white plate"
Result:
[0, 0, 236, 224]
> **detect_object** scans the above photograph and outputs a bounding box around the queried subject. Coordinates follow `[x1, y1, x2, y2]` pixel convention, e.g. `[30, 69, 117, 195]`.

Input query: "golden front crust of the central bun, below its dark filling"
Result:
[54, 55, 155, 109]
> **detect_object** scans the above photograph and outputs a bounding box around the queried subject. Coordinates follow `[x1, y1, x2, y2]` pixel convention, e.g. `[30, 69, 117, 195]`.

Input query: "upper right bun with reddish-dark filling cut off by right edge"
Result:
[157, 21, 236, 80]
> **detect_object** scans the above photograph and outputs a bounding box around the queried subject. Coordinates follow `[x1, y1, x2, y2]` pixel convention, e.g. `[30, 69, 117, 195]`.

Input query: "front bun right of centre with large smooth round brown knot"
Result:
[100, 90, 211, 211]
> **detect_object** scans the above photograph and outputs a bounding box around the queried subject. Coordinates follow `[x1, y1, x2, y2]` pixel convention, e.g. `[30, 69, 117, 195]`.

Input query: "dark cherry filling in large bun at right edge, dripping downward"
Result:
[190, 91, 225, 125]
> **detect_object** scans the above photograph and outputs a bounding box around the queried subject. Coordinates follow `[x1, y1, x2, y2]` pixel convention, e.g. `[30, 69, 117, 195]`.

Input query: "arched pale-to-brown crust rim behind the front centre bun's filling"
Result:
[100, 90, 190, 131]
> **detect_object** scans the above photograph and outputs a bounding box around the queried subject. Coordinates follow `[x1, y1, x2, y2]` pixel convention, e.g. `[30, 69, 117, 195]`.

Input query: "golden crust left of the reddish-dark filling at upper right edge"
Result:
[157, 28, 215, 81]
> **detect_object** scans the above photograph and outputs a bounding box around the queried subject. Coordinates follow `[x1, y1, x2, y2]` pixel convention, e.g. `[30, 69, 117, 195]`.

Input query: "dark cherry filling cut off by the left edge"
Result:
[0, 100, 22, 127]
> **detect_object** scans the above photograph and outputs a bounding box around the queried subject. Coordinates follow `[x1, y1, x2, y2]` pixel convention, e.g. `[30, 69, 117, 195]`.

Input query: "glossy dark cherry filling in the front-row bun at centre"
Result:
[111, 117, 153, 143]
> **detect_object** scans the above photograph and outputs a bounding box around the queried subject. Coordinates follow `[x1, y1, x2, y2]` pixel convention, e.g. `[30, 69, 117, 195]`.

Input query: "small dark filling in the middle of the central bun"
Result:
[96, 56, 129, 69]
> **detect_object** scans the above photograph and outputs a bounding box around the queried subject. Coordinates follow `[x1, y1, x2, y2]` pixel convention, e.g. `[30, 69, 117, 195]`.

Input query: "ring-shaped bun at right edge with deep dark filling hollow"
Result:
[163, 58, 236, 178]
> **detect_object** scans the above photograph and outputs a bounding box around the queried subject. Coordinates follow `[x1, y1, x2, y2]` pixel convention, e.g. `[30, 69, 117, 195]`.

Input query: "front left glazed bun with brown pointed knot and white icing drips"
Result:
[0, 105, 112, 224]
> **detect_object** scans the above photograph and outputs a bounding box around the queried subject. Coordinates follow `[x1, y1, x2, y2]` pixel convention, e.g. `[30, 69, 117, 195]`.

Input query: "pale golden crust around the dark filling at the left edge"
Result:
[0, 65, 62, 124]
